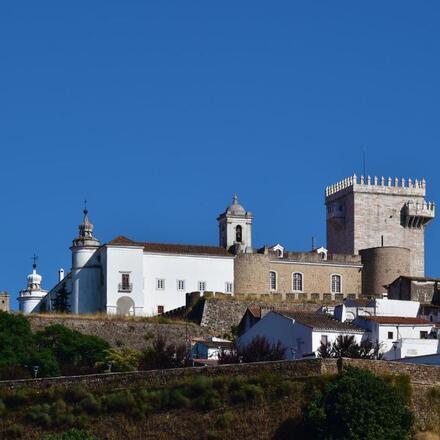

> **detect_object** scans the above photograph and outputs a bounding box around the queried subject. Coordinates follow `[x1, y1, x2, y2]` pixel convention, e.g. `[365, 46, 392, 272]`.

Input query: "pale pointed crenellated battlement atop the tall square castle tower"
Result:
[325, 174, 426, 197]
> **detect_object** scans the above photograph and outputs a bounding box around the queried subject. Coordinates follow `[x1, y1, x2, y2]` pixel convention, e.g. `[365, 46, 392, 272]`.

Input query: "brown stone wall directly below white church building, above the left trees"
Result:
[28, 315, 210, 350]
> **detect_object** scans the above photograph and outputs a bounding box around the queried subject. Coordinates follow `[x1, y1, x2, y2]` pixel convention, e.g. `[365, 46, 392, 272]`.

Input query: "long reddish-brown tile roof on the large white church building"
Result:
[107, 235, 232, 257]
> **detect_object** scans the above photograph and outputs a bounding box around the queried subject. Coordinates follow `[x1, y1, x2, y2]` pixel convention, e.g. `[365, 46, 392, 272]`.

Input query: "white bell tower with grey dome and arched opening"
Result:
[217, 194, 253, 254]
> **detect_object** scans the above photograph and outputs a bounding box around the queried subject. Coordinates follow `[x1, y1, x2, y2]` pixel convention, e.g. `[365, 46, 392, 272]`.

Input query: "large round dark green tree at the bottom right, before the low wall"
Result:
[304, 368, 413, 440]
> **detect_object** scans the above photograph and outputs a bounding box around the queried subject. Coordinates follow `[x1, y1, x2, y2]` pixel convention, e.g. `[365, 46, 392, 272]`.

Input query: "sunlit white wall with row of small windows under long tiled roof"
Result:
[143, 253, 234, 315]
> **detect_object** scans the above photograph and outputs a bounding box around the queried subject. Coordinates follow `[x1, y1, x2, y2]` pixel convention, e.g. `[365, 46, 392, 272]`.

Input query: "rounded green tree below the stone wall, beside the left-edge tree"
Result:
[36, 324, 110, 375]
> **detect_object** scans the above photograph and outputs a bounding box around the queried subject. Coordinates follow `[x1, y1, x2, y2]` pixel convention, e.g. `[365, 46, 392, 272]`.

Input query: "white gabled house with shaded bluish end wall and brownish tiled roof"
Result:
[237, 310, 364, 359]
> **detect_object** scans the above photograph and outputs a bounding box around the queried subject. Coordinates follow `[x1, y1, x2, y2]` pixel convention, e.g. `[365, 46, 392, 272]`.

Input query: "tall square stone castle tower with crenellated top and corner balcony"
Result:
[325, 175, 435, 276]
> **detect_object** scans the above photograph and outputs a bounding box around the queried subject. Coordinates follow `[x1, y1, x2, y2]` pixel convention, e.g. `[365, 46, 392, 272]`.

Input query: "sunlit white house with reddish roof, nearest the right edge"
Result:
[353, 316, 439, 360]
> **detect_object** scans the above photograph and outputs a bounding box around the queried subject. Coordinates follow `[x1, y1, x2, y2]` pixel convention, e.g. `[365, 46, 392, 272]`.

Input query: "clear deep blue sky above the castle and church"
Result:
[0, 0, 440, 310]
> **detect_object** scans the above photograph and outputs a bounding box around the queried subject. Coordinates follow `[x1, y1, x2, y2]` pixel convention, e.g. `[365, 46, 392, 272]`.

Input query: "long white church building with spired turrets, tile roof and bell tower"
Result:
[18, 196, 252, 316]
